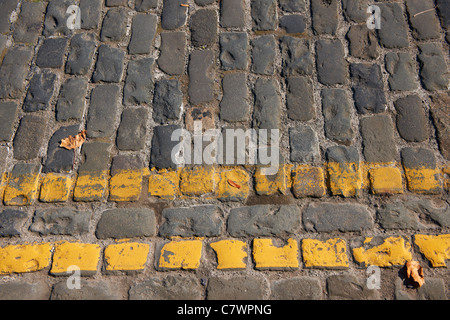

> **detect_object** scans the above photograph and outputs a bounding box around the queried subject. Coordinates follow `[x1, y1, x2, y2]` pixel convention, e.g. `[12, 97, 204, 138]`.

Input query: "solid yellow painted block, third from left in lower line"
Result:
[105, 242, 150, 271]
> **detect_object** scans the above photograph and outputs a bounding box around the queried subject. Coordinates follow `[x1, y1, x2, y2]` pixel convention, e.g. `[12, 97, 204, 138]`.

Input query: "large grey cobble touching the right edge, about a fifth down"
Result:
[418, 43, 448, 91]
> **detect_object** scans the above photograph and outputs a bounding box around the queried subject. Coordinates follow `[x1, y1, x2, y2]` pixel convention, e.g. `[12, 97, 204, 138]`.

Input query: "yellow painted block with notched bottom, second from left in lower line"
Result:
[50, 242, 101, 274]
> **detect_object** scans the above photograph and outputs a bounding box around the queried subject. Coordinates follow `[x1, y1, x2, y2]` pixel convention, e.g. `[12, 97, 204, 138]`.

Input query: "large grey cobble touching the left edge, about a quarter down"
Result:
[0, 47, 33, 99]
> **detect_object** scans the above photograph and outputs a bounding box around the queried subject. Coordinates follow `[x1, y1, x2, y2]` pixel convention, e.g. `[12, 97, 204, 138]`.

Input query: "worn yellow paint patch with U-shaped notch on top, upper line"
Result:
[254, 164, 292, 196]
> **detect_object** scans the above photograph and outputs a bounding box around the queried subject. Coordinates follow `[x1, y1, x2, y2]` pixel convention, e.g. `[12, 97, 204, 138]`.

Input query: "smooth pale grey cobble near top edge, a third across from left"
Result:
[128, 14, 158, 54]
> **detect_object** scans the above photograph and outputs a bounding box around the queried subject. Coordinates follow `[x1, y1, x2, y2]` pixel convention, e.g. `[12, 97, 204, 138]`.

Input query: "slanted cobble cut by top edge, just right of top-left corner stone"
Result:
[13, 2, 47, 44]
